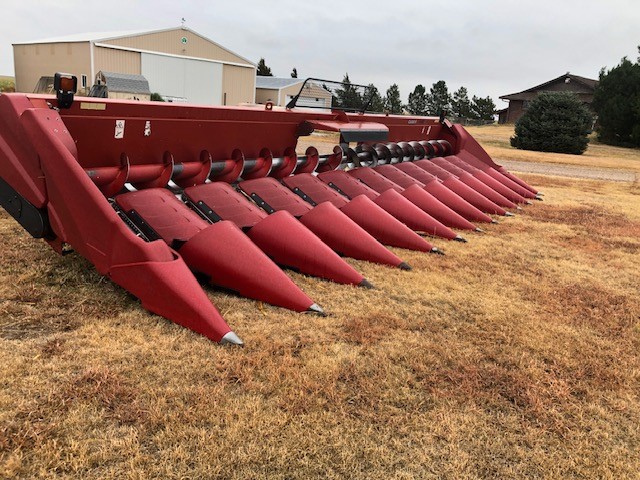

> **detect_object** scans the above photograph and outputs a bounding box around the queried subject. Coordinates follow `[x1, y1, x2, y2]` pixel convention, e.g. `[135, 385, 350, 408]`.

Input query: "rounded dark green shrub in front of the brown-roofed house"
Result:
[511, 92, 593, 155]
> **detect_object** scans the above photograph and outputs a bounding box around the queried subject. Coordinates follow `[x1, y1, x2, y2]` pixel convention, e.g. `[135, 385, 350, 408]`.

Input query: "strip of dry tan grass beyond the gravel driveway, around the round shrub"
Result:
[466, 125, 640, 172]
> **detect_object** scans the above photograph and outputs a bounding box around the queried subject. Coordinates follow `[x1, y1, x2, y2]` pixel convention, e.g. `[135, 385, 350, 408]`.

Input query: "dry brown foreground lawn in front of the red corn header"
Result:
[0, 127, 640, 479]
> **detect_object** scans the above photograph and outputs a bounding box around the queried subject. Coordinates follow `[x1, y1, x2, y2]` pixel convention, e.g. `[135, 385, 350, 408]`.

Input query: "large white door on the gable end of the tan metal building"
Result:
[141, 53, 222, 105]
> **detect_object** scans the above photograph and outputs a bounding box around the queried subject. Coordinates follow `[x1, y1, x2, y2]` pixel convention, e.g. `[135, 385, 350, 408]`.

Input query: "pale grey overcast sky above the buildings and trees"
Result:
[0, 0, 640, 108]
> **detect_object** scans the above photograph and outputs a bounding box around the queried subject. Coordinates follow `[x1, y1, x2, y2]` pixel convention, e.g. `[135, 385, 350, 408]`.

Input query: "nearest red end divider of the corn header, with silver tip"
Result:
[16, 109, 235, 343]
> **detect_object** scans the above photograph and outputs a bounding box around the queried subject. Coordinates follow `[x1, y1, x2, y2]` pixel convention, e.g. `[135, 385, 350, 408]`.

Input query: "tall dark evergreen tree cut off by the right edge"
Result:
[593, 47, 640, 147]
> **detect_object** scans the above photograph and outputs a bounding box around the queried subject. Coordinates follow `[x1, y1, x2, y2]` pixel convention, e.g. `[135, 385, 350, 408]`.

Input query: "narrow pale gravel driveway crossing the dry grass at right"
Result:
[495, 159, 640, 182]
